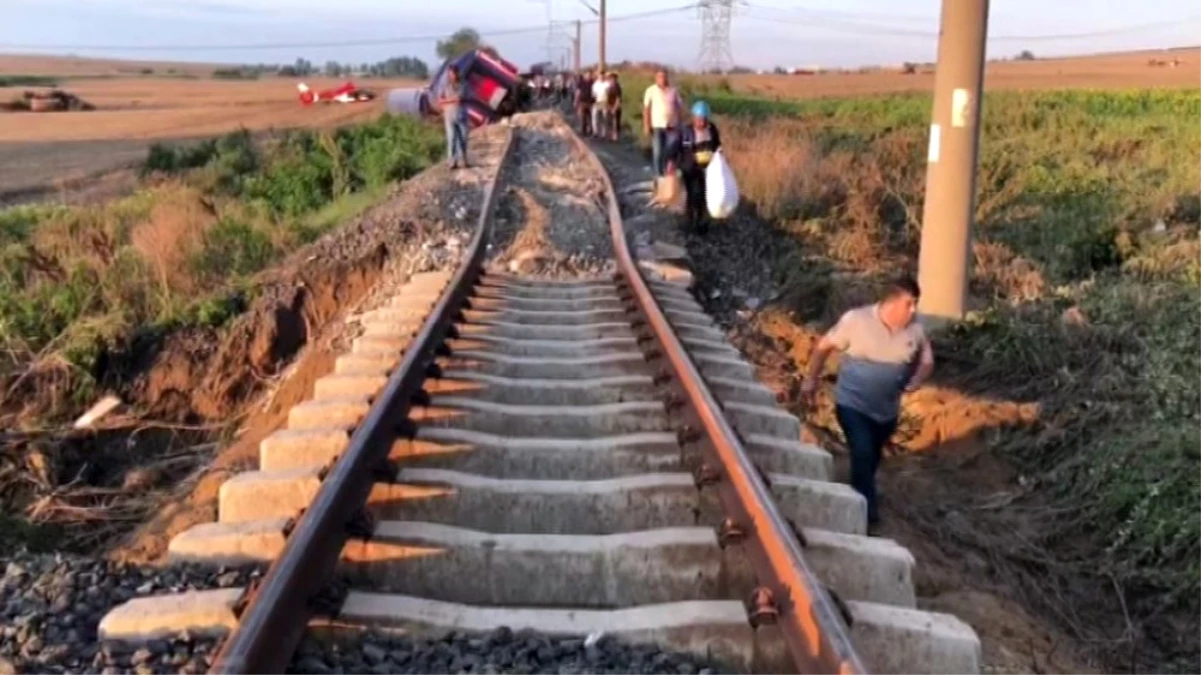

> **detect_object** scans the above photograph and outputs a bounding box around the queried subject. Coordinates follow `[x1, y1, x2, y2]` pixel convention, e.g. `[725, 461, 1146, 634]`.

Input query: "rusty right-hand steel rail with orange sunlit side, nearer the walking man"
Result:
[572, 127, 867, 675]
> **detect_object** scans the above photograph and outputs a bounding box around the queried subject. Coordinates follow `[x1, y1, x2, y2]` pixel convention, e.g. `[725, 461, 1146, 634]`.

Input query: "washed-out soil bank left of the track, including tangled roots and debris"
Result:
[0, 121, 507, 562]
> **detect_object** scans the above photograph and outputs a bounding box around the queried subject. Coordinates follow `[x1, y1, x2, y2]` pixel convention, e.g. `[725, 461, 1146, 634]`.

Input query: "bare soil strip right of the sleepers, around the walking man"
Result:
[586, 127, 1099, 675]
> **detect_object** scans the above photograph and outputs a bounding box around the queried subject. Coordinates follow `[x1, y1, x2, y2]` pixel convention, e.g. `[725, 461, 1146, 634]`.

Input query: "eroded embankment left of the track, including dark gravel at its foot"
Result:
[0, 124, 516, 673]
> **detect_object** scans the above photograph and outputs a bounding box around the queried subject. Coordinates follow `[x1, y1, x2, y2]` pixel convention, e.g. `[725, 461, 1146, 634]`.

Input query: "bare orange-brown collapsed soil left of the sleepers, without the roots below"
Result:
[106, 121, 507, 562]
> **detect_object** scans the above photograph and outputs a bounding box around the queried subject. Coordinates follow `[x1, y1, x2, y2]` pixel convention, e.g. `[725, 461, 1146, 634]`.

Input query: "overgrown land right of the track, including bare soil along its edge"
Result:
[610, 66, 1201, 673]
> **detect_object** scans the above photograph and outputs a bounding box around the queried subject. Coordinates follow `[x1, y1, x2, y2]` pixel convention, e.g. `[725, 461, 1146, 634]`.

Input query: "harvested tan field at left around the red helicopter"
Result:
[0, 56, 414, 203]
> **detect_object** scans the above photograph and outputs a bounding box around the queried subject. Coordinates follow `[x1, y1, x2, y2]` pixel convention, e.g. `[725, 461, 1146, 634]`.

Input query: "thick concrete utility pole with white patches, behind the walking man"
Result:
[918, 0, 988, 321]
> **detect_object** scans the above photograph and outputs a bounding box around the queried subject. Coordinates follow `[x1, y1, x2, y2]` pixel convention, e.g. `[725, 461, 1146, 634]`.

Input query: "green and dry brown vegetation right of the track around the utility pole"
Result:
[677, 84, 1201, 658]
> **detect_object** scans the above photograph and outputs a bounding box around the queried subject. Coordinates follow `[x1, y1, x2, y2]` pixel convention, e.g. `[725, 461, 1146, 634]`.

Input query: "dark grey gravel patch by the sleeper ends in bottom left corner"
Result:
[0, 554, 261, 675]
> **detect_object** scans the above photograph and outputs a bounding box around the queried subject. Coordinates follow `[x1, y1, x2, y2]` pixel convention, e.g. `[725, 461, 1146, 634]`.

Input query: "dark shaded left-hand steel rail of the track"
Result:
[209, 130, 514, 675]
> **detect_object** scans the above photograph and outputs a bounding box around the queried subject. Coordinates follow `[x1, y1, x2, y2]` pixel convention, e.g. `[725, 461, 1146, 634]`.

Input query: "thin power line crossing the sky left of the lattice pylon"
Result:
[0, 2, 697, 52]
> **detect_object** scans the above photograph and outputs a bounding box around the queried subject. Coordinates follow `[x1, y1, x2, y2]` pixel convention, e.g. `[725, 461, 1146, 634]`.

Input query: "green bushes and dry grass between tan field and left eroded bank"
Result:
[0, 117, 442, 423]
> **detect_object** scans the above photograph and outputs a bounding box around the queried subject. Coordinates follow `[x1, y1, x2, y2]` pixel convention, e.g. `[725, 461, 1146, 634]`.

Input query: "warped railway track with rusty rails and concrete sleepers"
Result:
[93, 115, 980, 674]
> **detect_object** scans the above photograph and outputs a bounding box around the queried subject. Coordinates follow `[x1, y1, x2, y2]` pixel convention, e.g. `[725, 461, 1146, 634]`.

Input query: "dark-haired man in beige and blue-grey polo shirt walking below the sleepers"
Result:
[801, 275, 934, 528]
